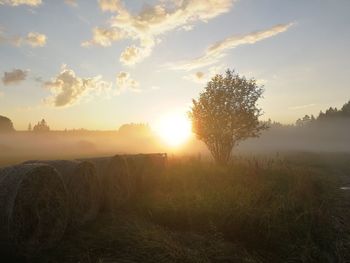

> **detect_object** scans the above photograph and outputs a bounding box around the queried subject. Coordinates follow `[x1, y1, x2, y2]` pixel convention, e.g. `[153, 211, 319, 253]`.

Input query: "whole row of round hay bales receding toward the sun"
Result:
[0, 154, 166, 256]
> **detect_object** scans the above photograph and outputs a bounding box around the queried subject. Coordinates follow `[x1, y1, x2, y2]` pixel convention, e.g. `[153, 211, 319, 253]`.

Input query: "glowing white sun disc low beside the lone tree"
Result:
[155, 113, 192, 147]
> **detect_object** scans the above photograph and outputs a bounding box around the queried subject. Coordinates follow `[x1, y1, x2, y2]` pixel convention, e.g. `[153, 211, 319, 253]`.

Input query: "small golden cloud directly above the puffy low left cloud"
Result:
[81, 27, 125, 47]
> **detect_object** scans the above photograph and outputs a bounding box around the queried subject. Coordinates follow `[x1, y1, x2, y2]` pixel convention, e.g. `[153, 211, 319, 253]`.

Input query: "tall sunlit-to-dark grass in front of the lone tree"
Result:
[139, 159, 338, 262]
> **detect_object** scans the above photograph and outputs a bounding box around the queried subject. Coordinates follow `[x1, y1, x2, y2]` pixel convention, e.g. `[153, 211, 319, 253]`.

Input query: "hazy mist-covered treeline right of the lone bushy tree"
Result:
[239, 102, 350, 153]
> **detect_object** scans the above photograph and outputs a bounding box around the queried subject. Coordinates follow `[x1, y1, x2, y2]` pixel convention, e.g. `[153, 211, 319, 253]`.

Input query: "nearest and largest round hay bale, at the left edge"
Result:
[0, 164, 68, 256]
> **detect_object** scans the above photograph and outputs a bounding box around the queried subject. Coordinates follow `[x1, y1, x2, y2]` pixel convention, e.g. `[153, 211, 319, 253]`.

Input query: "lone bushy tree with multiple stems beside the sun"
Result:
[189, 70, 267, 165]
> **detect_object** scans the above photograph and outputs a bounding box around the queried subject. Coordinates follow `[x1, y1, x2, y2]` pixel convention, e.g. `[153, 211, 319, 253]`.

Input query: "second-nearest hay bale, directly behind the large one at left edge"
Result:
[26, 160, 100, 227]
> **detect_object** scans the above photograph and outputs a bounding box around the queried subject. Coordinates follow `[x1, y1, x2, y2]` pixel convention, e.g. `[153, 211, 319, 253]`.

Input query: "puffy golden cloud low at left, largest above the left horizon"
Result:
[44, 65, 111, 107]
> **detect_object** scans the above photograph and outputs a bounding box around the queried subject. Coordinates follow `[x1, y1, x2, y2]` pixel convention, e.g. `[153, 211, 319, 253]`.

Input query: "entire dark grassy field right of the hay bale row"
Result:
[8, 156, 349, 263]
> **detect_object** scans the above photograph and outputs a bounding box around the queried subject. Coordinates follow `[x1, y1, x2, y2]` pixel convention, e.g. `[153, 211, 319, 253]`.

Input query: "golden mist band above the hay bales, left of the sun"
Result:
[0, 131, 162, 165]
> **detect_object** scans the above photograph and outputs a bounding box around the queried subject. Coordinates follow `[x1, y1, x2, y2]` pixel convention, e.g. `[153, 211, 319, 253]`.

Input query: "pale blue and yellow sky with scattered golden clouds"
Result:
[0, 0, 350, 130]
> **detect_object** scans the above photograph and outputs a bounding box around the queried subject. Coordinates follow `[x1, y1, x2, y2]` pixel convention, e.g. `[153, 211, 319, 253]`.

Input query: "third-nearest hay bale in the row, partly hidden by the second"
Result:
[81, 155, 130, 211]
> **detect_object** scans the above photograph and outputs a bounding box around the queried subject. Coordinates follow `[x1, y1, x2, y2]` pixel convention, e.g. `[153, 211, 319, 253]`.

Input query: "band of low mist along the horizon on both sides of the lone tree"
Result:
[0, 119, 350, 168]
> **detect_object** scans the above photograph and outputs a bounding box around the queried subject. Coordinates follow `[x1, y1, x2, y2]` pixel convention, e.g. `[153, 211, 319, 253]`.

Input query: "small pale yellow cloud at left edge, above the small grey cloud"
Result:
[0, 30, 47, 48]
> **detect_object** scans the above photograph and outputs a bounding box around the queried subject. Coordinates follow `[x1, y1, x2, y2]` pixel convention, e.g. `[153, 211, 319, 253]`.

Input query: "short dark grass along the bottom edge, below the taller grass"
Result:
[32, 213, 255, 263]
